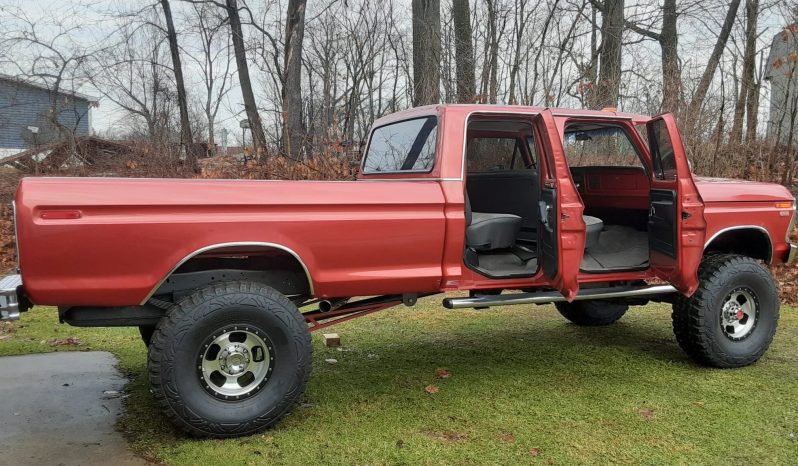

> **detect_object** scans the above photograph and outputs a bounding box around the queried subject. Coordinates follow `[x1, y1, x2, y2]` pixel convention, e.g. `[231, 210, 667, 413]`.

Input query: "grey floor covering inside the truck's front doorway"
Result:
[581, 225, 648, 272]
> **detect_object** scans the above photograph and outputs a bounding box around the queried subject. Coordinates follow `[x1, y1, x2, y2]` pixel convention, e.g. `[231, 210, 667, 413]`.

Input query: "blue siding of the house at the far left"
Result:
[0, 79, 90, 151]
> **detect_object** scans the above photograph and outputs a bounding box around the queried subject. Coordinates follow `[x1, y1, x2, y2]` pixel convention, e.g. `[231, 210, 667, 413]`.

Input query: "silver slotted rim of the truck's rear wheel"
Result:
[197, 326, 274, 400]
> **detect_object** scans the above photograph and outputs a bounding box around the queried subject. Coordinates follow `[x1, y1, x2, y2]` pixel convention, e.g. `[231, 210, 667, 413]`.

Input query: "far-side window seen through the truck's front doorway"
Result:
[563, 125, 642, 167]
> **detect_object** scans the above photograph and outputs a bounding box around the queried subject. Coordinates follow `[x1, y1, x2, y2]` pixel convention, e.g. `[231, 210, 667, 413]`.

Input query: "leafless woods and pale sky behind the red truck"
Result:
[0, 0, 798, 185]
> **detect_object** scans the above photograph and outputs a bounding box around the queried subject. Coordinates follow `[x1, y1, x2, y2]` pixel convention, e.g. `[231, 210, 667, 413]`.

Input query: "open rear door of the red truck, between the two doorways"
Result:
[535, 110, 585, 302]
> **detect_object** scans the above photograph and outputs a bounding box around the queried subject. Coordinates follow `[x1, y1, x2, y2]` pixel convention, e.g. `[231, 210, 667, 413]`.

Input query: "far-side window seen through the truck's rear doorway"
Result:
[466, 137, 532, 173]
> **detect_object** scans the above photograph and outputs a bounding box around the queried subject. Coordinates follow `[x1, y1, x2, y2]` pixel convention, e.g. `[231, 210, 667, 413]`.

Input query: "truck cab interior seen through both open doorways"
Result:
[464, 118, 650, 278]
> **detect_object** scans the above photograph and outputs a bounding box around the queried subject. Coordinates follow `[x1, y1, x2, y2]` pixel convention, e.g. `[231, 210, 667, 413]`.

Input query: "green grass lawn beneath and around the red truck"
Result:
[0, 297, 798, 464]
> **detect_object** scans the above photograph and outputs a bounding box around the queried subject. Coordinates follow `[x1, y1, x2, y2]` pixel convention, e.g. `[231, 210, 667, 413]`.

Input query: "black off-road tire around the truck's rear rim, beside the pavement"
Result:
[148, 281, 313, 438]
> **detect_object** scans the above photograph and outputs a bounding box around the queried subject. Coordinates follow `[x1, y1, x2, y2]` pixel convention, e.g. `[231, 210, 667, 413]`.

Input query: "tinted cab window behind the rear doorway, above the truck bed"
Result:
[362, 116, 438, 174]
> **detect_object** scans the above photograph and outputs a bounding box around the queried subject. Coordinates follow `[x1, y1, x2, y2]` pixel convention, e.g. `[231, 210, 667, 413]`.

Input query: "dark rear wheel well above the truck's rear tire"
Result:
[153, 245, 313, 300]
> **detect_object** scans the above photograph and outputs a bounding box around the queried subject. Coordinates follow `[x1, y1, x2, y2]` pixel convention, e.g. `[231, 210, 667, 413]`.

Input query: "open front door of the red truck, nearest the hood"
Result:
[646, 113, 706, 296]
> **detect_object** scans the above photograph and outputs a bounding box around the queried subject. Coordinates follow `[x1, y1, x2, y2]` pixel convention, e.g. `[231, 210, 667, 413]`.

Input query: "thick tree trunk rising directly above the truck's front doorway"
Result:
[595, 0, 624, 109]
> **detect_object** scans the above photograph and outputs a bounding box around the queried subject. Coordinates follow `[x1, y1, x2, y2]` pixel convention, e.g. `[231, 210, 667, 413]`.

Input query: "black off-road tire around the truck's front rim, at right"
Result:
[672, 254, 779, 368]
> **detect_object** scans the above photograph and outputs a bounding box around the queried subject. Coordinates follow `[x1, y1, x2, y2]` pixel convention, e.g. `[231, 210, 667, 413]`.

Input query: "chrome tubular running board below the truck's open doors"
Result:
[443, 285, 676, 309]
